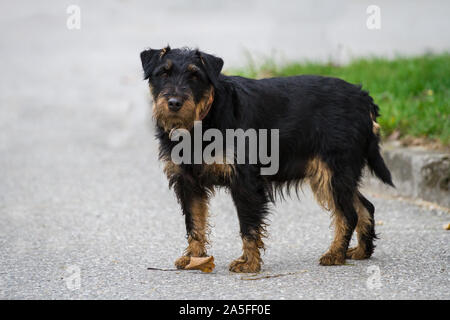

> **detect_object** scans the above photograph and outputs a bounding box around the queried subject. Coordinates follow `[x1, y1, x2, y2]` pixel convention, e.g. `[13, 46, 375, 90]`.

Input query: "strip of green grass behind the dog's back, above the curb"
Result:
[229, 53, 450, 146]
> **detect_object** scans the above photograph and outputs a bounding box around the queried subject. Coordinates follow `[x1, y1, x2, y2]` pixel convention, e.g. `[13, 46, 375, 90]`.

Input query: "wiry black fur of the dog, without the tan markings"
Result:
[141, 48, 393, 270]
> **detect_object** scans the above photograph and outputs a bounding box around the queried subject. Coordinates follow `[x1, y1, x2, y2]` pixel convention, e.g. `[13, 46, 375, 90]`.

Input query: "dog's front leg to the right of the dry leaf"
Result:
[229, 168, 268, 272]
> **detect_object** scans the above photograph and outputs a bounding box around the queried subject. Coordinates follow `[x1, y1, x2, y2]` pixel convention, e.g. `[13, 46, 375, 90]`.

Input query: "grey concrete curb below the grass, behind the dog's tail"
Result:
[364, 142, 450, 208]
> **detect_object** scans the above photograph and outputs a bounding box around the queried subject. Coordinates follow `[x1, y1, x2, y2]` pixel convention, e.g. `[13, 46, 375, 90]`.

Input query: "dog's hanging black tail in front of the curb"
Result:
[367, 102, 395, 188]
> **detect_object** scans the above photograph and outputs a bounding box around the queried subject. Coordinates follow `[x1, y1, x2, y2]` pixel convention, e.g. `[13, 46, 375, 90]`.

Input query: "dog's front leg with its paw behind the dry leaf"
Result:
[171, 179, 208, 269]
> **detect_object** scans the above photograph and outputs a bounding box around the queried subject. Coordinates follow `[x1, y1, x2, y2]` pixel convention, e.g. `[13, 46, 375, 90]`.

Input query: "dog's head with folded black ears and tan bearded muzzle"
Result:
[141, 46, 223, 132]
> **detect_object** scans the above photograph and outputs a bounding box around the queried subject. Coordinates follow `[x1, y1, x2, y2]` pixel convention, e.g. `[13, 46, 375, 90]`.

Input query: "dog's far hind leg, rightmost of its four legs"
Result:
[347, 192, 377, 260]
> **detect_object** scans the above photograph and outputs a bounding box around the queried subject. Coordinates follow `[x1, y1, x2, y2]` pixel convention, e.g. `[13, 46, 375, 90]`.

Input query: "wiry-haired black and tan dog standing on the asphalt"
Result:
[141, 47, 393, 272]
